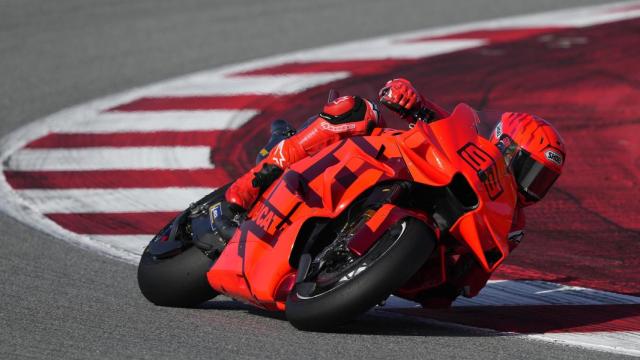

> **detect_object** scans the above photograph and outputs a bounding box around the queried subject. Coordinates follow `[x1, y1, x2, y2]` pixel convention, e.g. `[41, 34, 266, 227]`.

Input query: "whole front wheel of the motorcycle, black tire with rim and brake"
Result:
[286, 217, 436, 330]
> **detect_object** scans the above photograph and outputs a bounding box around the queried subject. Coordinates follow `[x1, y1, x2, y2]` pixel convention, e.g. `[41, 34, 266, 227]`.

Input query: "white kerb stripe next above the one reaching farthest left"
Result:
[56, 110, 258, 134]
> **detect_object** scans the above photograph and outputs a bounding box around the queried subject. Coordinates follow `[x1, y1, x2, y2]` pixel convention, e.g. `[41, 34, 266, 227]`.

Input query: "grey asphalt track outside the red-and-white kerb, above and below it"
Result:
[0, 0, 622, 359]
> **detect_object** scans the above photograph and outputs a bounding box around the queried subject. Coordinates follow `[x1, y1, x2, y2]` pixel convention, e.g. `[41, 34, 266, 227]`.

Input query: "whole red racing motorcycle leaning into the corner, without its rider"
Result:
[138, 104, 517, 330]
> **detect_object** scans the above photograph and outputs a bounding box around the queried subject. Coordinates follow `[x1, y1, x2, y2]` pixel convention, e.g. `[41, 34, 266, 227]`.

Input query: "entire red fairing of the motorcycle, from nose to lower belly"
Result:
[207, 104, 516, 310]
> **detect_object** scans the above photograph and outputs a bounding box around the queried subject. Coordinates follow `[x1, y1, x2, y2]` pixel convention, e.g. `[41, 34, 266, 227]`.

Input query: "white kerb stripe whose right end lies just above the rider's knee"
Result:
[145, 71, 351, 96]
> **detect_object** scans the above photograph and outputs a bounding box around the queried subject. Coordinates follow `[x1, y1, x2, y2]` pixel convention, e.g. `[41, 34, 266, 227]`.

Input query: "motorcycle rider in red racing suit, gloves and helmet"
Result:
[214, 78, 565, 307]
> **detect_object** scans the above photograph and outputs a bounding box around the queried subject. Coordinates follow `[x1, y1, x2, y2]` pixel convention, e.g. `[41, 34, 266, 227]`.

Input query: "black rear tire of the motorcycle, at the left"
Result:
[138, 246, 218, 307]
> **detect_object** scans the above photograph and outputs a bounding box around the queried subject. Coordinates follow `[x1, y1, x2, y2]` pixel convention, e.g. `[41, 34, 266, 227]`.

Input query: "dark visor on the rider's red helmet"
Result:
[511, 149, 560, 201]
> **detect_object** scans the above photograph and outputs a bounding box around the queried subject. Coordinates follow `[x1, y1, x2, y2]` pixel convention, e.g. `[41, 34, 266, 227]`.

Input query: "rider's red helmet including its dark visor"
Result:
[491, 113, 565, 206]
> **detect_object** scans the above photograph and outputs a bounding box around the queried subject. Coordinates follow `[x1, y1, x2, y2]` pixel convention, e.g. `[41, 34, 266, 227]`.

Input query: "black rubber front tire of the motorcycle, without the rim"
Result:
[286, 218, 436, 331]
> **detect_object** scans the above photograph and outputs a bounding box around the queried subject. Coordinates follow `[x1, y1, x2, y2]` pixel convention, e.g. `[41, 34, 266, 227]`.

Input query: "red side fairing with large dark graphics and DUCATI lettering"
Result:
[207, 137, 410, 309]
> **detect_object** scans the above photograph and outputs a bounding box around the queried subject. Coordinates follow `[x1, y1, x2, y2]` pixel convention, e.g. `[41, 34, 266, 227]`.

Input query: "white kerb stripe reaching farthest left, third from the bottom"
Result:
[5, 146, 213, 171]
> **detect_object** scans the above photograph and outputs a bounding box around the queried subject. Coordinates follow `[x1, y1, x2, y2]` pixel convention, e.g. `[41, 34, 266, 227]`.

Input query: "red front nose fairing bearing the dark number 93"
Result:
[400, 104, 517, 272]
